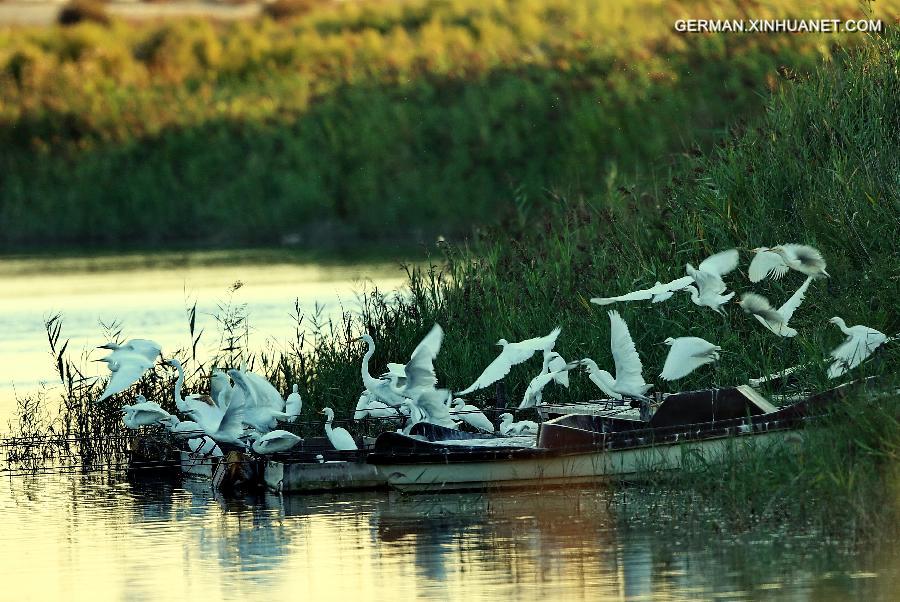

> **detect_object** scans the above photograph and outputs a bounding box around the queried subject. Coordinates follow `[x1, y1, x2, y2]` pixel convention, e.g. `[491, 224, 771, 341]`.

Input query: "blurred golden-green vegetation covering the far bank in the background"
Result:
[0, 0, 898, 249]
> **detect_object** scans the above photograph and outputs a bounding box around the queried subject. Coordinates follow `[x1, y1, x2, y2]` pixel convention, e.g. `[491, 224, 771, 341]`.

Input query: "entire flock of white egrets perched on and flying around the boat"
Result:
[99, 244, 890, 455]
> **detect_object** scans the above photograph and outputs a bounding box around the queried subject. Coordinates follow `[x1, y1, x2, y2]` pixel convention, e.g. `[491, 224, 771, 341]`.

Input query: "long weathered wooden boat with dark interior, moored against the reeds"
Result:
[369, 382, 880, 492]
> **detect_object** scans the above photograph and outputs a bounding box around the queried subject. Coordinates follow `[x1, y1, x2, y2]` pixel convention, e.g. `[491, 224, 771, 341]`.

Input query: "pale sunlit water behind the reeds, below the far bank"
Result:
[0, 251, 405, 422]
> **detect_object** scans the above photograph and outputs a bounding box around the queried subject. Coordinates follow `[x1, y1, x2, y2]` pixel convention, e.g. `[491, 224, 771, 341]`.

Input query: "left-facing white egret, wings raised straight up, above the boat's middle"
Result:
[580, 311, 653, 399]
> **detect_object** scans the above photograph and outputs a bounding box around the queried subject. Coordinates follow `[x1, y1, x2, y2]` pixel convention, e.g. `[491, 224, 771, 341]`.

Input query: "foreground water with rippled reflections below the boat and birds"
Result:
[0, 475, 898, 600]
